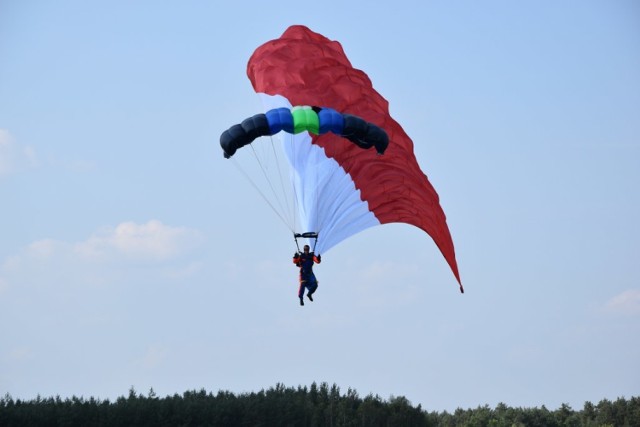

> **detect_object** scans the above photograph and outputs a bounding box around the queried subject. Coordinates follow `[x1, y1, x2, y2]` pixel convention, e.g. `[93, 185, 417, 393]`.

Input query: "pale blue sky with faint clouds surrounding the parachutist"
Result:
[0, 0, 640, 411]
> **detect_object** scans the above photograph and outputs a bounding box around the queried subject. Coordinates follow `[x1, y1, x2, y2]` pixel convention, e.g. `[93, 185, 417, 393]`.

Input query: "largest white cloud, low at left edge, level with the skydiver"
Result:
[0, 220, 202, 295]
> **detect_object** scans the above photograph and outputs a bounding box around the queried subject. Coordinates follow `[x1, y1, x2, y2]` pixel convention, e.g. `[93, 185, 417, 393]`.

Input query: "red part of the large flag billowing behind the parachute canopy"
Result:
[247, 25, 464, 292]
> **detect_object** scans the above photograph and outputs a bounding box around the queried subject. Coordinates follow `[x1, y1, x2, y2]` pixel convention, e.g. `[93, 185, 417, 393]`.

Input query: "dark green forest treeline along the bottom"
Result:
[0, 383, 640, 427]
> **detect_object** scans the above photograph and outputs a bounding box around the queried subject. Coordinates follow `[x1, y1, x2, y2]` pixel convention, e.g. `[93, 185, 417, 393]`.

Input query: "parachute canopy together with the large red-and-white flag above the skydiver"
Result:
[220, 25, 464, 292]
